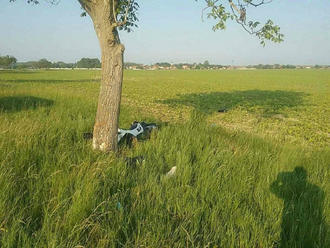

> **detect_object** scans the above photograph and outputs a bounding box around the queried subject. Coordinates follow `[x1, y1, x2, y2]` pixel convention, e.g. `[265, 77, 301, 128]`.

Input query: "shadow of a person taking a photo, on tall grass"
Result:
[270, 167, 327, 248]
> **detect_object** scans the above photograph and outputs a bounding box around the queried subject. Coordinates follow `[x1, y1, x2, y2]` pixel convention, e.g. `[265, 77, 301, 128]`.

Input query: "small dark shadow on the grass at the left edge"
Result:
[0, 96, 54, 112]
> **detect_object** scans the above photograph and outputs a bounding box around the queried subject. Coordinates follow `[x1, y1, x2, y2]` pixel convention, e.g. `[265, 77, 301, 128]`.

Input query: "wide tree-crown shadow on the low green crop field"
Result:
[161, 90, 306, 116]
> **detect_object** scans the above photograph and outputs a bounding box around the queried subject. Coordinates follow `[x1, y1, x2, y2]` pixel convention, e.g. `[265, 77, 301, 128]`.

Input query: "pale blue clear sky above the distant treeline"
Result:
[0, 0, 330, 65]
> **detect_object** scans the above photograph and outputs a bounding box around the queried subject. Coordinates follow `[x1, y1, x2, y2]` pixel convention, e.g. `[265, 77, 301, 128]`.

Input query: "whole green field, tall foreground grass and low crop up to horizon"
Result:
[0, 70, 330, 248]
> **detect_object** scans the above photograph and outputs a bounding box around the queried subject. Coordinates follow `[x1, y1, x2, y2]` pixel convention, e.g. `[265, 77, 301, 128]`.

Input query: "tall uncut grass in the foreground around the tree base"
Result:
[0, 69, 330, 248]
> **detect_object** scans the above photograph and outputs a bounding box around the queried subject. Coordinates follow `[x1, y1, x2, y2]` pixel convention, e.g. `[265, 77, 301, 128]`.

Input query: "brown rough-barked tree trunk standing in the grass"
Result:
[84, 0, 125, 151]
